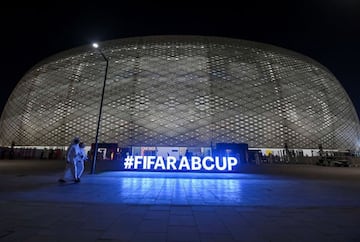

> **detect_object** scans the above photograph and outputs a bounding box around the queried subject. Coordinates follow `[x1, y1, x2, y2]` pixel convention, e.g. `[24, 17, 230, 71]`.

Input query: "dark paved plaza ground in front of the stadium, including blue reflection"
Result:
[0, 160, 360, 242]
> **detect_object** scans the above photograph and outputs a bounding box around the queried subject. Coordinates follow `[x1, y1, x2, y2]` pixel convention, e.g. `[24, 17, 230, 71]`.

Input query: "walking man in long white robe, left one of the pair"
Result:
[58, 137, 81, 183]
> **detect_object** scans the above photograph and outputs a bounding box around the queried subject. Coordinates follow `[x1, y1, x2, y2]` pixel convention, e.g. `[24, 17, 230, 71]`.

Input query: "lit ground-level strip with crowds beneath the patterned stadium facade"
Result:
[0, 146, 360, 167]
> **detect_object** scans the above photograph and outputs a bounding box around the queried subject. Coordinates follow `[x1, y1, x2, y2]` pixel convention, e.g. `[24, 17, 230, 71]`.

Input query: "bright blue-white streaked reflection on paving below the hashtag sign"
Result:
[116, 177, 242, 204]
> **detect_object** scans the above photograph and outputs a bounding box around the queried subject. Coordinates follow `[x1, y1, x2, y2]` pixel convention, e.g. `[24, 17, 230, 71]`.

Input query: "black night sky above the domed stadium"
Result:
[0, 3, 360, 116]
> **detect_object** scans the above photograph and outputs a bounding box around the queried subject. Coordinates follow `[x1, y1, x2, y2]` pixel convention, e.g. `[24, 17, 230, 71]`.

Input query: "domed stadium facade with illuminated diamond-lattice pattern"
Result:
[0, 36, 359, 149]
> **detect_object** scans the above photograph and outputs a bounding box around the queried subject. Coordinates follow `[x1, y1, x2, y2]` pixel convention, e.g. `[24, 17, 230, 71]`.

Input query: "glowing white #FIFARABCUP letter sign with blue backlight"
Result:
[124, 156, 239, 172]
